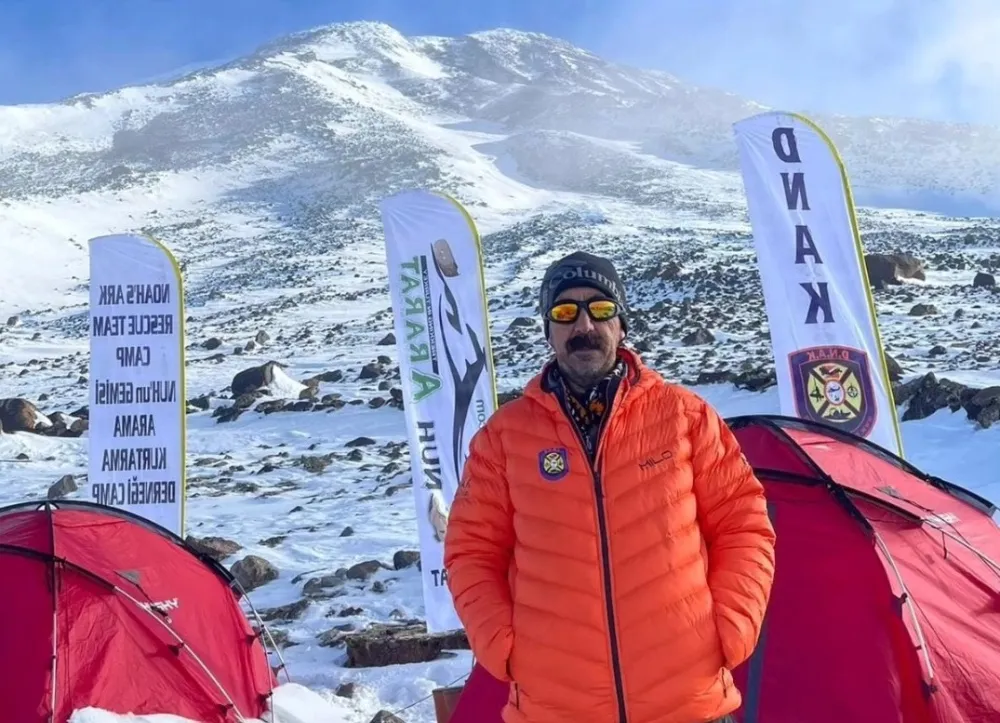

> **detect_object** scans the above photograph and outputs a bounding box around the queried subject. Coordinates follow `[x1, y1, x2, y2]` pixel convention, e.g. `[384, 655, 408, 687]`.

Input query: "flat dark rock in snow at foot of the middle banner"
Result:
[344, 622, 469, 668]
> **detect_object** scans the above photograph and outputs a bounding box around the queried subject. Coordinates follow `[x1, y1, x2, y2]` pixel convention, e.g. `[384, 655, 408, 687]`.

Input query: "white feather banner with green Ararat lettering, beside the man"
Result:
[381, 191, 496, 632]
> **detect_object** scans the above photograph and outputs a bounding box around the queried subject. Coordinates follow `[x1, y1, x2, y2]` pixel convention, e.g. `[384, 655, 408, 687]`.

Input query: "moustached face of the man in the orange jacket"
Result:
[546, 287, 625, 389]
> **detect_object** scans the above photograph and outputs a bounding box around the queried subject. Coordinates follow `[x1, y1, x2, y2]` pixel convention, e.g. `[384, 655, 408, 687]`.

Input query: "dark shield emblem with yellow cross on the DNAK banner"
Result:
[788, 346, 878, 437]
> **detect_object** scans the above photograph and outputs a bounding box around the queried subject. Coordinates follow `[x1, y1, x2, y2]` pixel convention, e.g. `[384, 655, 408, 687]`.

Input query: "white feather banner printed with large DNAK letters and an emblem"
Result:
[733, 112, 903, 456]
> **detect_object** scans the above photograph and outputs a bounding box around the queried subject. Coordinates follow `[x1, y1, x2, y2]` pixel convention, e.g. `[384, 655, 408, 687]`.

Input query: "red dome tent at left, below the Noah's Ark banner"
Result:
[0, 502, 275, 723]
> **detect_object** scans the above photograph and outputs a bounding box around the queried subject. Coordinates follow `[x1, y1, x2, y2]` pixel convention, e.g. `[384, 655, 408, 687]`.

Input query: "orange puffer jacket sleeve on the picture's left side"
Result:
[444, 424, 514, 681]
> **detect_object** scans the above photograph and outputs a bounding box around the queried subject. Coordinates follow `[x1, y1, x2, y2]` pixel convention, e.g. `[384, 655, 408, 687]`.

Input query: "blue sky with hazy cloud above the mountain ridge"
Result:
[0, 0, 1000, 124]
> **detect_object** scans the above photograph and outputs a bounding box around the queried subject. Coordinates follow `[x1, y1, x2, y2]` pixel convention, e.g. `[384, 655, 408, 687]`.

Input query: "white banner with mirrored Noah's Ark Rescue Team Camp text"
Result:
[83, 235, 187, 535]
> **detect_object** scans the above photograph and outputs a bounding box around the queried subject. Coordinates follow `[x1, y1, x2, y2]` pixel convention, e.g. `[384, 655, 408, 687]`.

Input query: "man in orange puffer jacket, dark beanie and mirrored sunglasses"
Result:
[445, 252, 775, 723]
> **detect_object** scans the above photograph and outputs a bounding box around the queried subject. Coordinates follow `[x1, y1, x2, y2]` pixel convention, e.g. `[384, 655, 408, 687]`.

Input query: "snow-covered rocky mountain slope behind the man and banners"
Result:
[0, 23, 1000, 723]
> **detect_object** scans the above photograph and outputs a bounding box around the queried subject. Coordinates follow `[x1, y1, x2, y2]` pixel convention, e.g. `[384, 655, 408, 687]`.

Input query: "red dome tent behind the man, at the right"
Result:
[452, 416, 1000, 723]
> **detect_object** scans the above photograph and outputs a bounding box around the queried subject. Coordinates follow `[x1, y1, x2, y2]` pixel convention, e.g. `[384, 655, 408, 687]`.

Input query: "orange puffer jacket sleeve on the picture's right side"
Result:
[691, 402, 775, 669]
